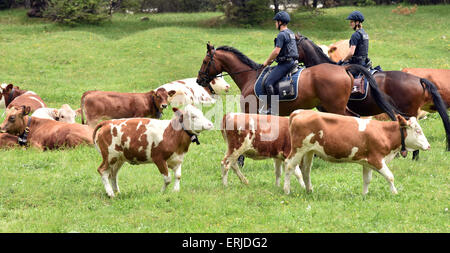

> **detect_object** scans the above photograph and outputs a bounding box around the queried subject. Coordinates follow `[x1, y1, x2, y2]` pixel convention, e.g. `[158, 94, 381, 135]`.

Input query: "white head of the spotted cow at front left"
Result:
[173, 105, 214, 134]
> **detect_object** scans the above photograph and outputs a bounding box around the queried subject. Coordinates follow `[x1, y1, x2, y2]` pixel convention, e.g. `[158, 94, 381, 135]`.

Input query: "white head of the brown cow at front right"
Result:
[397, 115, 431, 151]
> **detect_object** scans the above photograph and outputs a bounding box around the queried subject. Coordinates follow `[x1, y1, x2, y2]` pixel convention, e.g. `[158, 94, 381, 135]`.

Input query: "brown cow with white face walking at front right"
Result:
[284, 110, 430, 194]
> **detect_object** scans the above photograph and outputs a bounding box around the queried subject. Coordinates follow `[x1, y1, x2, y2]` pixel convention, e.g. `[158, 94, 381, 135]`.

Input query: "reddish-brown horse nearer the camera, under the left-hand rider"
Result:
[197, 43, 395, 118]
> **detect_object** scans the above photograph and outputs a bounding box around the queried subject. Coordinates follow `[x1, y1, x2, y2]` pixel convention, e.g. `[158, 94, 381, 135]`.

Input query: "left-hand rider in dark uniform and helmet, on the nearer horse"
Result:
[260, 11, 298, 114]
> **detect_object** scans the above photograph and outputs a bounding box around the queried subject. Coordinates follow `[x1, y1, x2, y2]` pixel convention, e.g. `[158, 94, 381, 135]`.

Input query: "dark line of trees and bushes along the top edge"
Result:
[0, 0, 450, 24]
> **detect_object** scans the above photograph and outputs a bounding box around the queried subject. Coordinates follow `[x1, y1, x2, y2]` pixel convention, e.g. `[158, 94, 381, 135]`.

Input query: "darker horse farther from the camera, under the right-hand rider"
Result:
[296, 34, 450, 151]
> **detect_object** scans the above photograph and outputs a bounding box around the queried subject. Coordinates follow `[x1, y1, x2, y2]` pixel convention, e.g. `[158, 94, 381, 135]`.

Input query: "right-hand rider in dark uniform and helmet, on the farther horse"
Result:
[338, 11, 370, 68]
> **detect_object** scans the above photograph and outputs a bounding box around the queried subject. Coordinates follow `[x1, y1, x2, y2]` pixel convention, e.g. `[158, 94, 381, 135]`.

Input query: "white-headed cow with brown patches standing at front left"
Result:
[93, 105, 213, 197]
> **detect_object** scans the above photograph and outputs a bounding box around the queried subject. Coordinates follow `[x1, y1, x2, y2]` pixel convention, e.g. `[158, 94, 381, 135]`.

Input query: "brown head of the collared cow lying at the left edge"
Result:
[0, 105, 31, 135]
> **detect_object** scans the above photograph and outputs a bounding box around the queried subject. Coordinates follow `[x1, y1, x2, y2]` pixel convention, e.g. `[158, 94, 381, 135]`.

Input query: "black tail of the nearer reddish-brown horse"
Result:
[344, 64, 398, 121]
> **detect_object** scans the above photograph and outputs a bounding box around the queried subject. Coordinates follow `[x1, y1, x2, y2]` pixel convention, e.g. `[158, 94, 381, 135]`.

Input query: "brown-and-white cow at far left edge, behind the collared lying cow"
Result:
[0, 83, 47, 111]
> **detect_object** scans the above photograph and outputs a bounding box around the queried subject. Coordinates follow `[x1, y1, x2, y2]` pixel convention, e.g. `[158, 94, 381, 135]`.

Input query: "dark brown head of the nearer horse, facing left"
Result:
[197, 42, 222, 93]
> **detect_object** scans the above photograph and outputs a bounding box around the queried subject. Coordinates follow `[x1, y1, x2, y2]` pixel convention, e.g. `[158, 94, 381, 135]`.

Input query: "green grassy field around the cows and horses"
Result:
[0, 5, 450, 233]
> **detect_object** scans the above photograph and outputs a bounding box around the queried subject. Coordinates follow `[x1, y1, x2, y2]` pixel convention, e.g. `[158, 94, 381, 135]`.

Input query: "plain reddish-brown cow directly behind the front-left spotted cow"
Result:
[81, 89, 175, 128]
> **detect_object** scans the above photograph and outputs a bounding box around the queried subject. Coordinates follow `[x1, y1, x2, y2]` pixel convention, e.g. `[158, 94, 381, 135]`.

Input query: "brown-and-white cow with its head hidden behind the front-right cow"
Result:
[221, 113, 305, 187]
